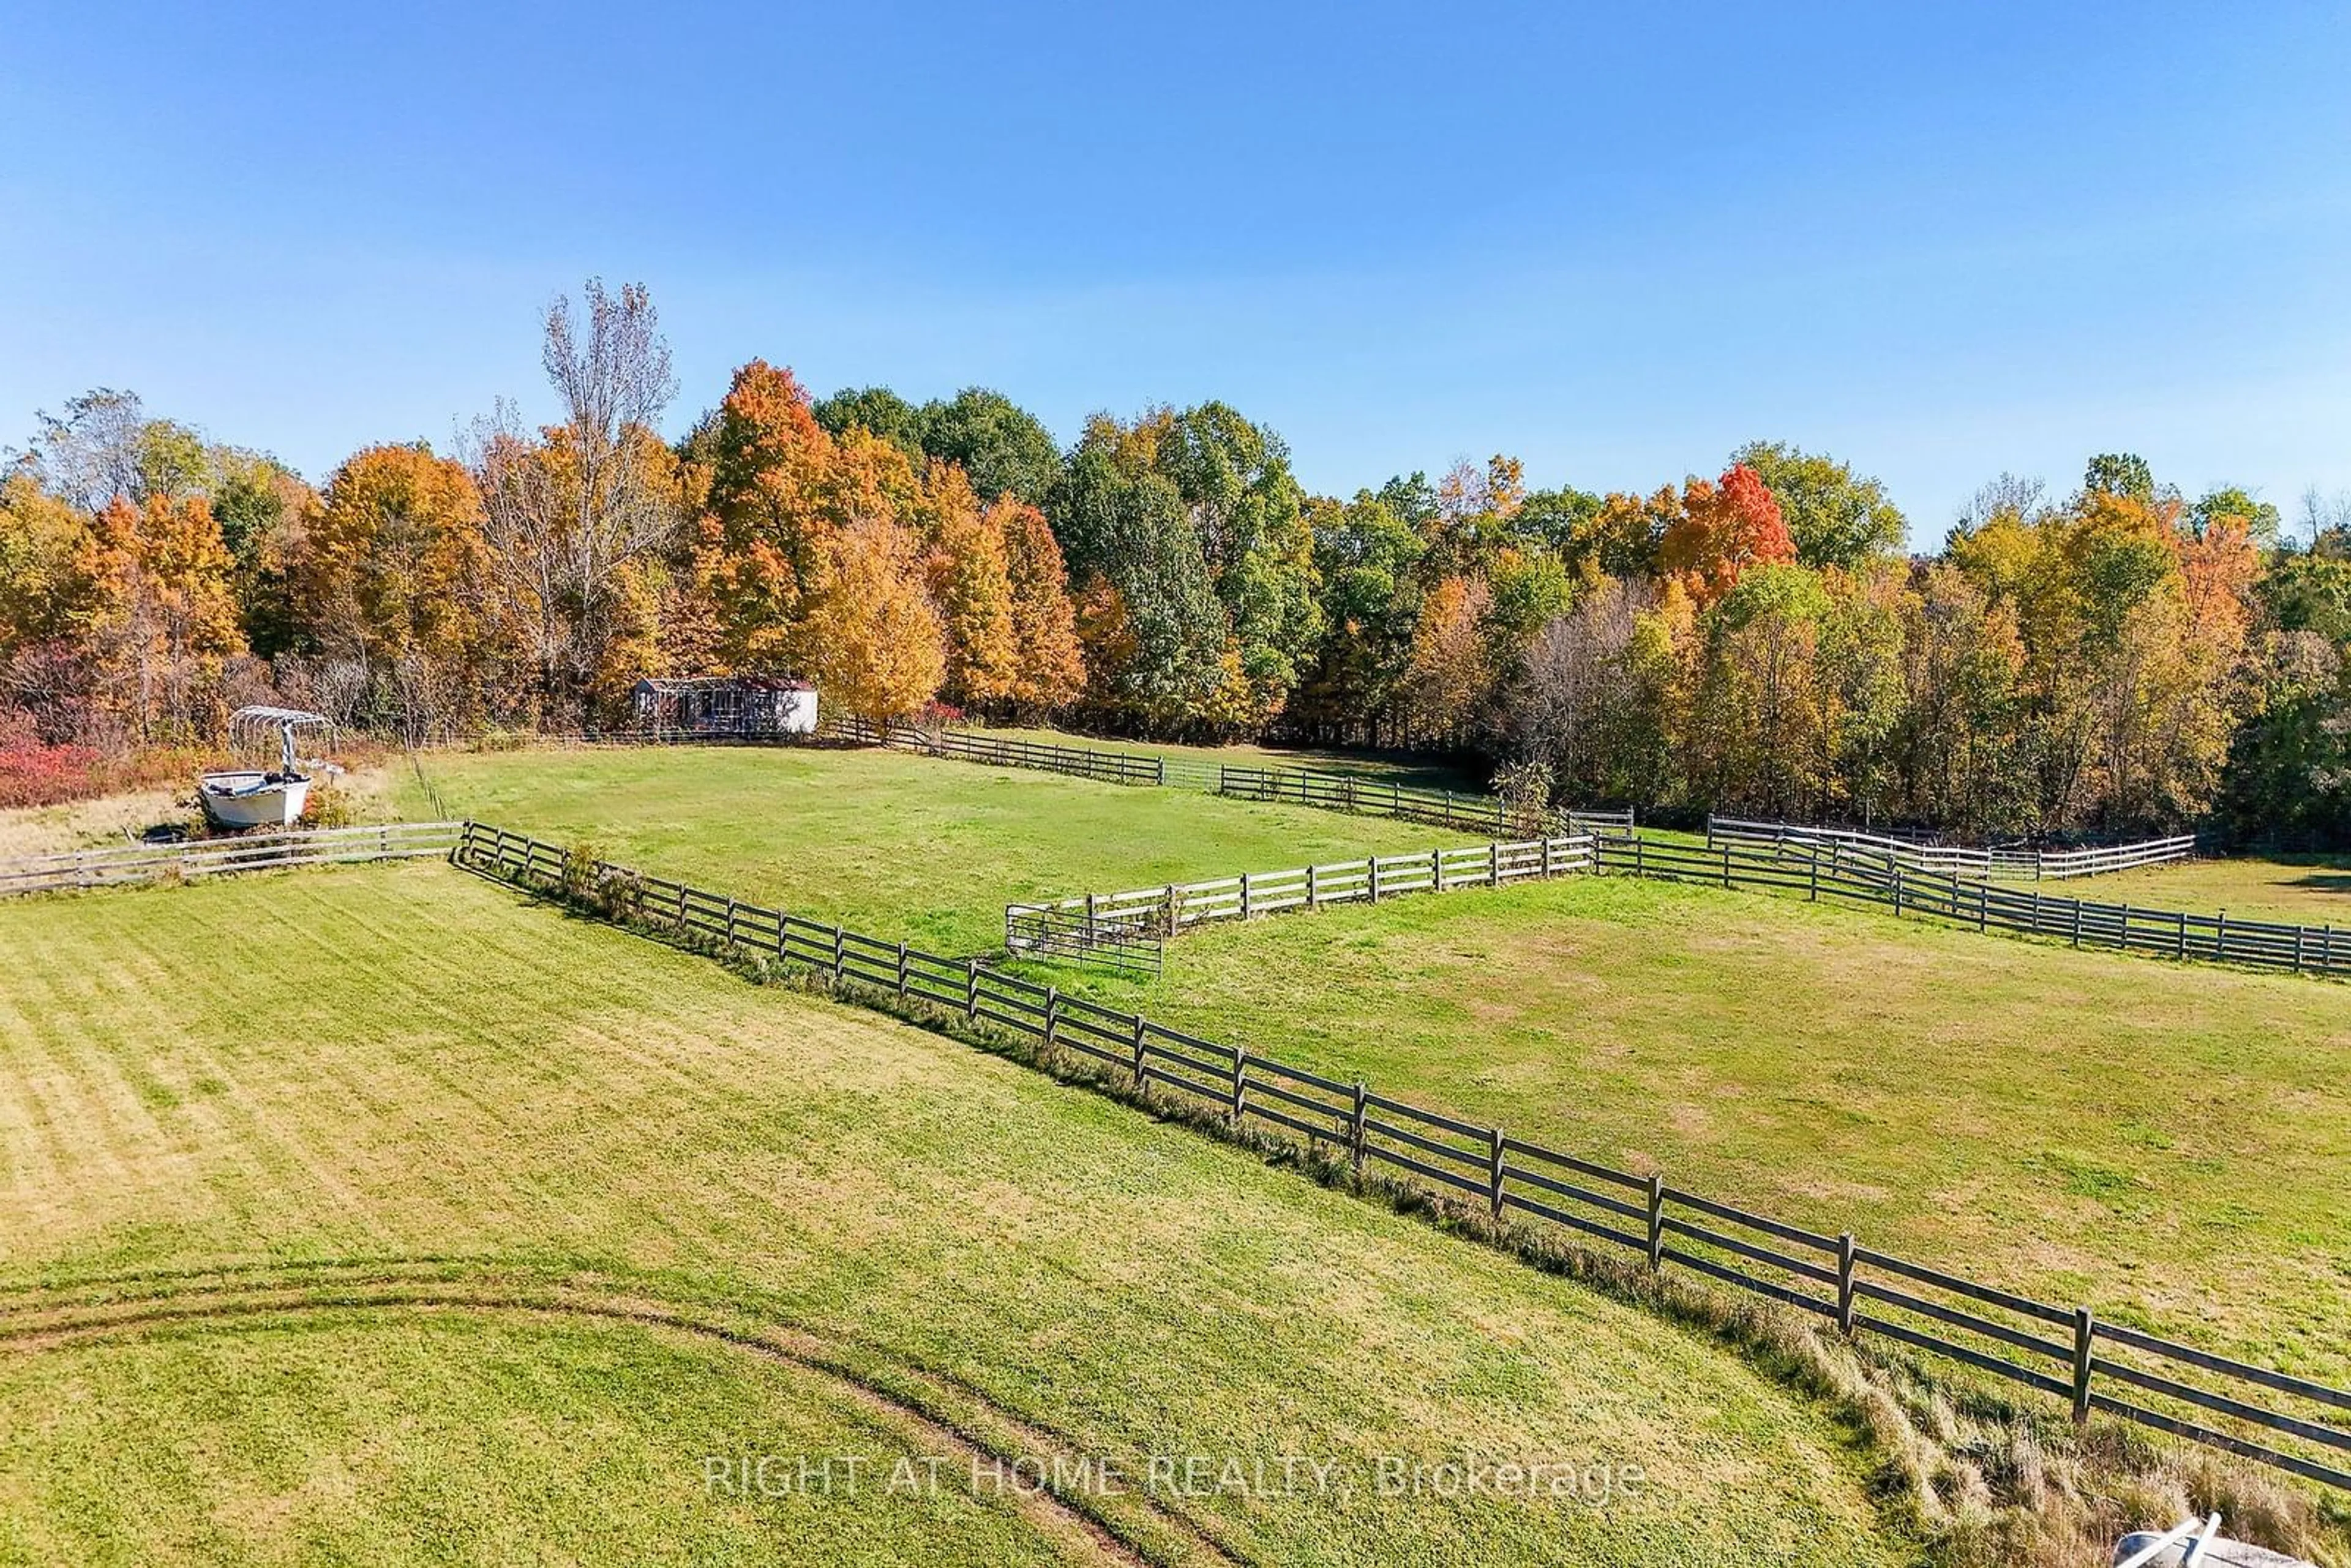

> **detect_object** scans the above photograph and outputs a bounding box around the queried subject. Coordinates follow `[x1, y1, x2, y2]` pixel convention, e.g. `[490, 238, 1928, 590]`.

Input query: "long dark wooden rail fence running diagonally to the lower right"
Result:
[451, 823, 2351, 1490]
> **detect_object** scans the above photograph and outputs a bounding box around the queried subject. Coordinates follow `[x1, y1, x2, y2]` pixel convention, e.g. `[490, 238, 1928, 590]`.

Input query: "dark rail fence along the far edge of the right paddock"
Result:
[1592, 832, 2351, 975]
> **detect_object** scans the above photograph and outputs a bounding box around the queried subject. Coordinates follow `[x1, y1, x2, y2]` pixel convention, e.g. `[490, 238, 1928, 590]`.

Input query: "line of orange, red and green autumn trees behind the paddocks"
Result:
[0, 282, 2351, 844]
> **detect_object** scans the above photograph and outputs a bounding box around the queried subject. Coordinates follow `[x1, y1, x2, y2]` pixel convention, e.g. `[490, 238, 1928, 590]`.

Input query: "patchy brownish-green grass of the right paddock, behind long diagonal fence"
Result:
[1070, 877, 2351, 1382]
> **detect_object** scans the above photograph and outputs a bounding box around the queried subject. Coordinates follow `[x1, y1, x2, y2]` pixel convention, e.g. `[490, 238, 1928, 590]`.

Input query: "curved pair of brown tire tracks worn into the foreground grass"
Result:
[0, 1258, 1246, 1568]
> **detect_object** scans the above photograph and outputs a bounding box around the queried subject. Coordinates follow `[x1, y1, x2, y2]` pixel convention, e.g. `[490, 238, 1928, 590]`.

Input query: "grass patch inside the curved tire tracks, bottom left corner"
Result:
[0, 1310, 1081, 1566]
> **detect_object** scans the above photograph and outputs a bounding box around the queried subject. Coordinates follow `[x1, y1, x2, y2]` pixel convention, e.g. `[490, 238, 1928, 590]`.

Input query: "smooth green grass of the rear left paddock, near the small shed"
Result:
[402, 748, 1462, 955]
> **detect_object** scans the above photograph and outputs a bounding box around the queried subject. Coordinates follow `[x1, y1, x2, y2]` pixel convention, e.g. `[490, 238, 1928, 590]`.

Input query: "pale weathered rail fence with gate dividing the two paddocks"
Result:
[1004, 835, 1592, 973]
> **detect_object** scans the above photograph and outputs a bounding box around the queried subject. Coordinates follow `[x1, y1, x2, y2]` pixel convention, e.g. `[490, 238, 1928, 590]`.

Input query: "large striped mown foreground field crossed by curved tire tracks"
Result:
[0, 865, 1909, 1568]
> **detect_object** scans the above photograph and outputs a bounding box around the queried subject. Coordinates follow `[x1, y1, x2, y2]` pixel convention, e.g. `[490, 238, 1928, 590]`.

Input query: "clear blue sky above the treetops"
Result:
[0, 2, 2351, 546]
